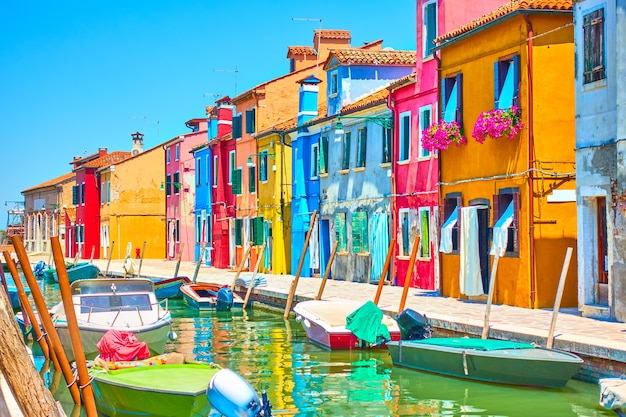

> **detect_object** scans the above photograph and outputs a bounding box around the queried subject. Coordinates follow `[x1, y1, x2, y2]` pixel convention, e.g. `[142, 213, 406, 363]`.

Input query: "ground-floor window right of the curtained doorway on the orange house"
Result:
[491, 188, 519, 254]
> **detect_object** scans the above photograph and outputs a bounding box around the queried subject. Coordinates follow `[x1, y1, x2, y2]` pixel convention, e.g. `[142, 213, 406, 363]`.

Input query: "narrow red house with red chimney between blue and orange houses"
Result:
[208, 96, 237, 268]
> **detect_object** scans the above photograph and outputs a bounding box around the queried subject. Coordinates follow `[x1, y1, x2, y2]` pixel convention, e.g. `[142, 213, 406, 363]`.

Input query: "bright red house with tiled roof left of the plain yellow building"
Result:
[65, 146, 134, 259]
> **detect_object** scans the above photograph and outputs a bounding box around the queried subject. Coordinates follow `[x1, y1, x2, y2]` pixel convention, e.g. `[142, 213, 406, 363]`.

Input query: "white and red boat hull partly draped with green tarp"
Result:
[294, 301, 400, 350]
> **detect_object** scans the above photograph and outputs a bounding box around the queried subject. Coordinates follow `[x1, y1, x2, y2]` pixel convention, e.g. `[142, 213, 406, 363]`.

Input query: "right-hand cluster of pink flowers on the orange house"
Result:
[472, 106, 524, 143]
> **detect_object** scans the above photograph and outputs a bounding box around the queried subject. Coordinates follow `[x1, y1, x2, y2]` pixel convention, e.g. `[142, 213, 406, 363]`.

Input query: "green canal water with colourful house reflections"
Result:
[28, 283, 604, 417]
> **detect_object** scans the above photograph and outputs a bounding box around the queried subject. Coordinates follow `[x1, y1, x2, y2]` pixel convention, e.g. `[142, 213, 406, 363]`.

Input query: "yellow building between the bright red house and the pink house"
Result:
[98, 145, 165, 259]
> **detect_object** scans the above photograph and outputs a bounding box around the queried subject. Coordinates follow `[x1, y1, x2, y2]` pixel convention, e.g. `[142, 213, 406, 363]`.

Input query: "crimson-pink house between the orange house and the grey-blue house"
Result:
[389, 0, 504, 291]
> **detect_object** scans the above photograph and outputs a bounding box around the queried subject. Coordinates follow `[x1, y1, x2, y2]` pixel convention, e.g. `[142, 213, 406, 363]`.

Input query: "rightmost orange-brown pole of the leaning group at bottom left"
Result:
[50, 236, 98, 417]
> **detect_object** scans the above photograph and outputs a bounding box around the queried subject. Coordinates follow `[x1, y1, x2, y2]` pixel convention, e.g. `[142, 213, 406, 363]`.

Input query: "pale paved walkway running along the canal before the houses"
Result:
[24, 257, 626, 380]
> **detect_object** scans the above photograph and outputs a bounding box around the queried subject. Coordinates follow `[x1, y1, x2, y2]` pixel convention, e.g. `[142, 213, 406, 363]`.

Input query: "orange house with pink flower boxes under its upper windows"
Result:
[430, 0, 577, 308]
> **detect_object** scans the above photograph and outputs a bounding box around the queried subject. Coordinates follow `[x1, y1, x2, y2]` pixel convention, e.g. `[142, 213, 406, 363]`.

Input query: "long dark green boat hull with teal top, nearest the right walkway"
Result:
[388, 338, 582, 388]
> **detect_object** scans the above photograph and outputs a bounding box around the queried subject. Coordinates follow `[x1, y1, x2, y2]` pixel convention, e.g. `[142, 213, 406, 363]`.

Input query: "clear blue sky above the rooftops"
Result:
[0, 0, 415, 229]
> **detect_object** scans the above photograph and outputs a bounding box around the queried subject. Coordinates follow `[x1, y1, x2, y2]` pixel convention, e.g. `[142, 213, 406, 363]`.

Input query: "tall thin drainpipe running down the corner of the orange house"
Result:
[524, 15, 537, 308]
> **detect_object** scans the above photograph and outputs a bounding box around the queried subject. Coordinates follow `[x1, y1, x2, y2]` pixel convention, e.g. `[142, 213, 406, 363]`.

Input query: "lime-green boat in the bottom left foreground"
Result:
[91, 363, 222, 417]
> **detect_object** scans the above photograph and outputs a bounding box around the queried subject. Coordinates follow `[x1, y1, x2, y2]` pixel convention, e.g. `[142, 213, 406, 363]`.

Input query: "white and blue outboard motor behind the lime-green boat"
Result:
[206, 369, 272, 417]
